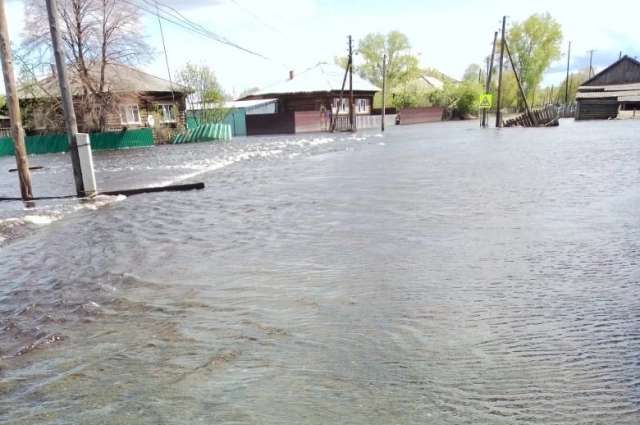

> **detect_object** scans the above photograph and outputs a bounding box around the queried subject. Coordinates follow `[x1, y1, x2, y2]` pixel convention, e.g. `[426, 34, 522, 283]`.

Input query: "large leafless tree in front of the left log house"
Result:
[20, 0, 153, 131]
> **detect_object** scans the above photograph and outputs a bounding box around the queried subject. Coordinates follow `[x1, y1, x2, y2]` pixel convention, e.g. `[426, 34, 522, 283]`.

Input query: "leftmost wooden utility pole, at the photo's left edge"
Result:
[0, 0, 33, 200]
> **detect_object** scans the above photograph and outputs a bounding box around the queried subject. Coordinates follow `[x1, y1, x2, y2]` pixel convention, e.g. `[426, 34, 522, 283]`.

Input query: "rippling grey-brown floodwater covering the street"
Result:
[0, 120, 640, 425]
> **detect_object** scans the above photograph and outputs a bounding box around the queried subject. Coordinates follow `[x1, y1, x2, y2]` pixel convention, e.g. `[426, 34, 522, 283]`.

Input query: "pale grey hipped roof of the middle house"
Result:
[240, 64, 380, 100]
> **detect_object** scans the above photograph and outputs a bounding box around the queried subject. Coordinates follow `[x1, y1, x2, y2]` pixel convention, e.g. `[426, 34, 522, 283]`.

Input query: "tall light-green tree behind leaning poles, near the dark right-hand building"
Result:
[507, 13, 562, 105]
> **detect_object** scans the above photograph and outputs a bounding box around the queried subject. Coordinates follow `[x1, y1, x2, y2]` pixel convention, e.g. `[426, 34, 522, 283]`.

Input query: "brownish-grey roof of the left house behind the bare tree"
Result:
[18, 63, 187, 99]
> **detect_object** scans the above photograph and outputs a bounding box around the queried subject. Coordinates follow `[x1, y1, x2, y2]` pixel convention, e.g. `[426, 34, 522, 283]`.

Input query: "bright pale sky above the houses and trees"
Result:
[1, 0, 640, 94]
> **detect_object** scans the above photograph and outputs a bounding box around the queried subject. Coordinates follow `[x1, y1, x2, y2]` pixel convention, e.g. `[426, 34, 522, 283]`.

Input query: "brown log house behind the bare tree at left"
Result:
[18, 64, 188, 134]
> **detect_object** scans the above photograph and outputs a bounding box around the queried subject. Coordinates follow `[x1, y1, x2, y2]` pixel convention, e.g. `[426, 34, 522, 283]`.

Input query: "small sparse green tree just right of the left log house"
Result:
[175, 62, 230, 125]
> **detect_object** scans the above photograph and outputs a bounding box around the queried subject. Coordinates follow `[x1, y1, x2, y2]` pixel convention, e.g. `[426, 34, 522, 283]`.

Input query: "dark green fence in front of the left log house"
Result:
[0, 128, 153, 155]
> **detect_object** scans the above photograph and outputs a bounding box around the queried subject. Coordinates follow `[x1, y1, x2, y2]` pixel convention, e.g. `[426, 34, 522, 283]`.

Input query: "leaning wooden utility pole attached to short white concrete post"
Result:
[46, 0, 85, 197]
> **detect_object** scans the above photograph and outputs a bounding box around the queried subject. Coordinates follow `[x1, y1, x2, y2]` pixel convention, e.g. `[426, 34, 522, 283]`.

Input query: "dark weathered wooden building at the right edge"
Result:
[575, 56, 640, 120]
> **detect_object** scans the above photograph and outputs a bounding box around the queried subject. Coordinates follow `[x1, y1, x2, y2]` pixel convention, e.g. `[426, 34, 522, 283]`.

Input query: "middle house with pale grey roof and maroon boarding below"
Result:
[238, 64, 380, 135]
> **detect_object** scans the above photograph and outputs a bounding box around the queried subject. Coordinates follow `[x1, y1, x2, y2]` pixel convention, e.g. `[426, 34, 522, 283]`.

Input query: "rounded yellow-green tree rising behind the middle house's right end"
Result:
[350, 31, 420, 88]
